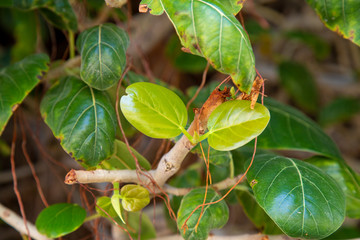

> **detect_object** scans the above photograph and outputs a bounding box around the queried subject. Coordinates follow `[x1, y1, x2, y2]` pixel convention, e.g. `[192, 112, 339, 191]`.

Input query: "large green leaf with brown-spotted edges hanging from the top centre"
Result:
[141, 0, 255, 93]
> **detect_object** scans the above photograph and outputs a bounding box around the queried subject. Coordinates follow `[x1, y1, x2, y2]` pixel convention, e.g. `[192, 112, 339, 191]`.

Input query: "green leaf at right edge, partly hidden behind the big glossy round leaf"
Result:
[306, 156, 360, 218]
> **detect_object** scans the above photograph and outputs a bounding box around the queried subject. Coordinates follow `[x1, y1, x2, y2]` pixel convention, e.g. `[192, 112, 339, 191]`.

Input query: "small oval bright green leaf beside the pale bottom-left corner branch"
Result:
[36, 203, 86, 238]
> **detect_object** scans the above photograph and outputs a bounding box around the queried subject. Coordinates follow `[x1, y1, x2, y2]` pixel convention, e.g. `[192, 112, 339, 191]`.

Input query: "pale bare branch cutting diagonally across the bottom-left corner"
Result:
[0, 204, 49, 240]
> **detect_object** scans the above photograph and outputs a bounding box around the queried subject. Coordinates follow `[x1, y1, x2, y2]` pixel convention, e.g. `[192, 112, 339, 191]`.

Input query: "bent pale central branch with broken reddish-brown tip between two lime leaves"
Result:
[65, 88, 229, 187]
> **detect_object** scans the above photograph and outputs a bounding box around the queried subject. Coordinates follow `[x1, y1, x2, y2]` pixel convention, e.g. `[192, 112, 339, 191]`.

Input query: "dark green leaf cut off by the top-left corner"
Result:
[0, 0, 77, 31]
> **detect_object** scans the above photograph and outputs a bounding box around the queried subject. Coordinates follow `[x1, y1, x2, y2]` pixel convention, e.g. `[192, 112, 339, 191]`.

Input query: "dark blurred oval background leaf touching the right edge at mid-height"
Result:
[319, 97, 360, 126]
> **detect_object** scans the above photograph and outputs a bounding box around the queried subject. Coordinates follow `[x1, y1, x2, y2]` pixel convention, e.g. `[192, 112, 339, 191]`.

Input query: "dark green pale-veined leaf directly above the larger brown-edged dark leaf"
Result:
[76, 23, 129, 90]
